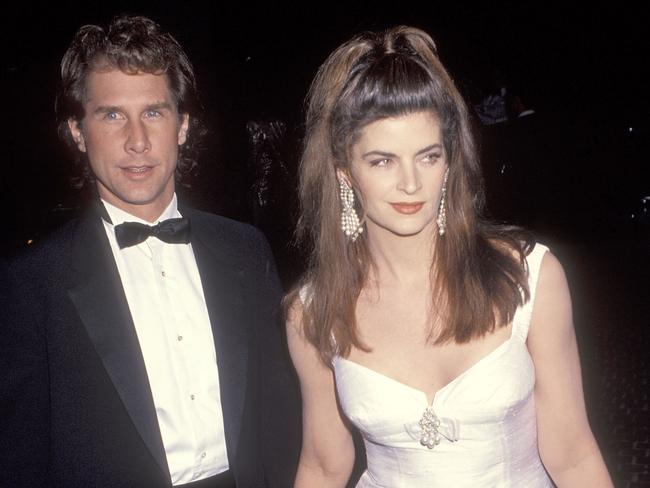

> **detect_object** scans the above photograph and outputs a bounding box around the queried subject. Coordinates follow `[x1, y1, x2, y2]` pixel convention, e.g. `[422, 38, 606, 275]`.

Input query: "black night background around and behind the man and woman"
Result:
[0, 1, 650, 487]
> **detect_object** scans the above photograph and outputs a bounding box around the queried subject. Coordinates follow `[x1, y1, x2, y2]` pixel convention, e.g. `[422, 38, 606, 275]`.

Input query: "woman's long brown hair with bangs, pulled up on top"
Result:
[287, 26, 532, 363]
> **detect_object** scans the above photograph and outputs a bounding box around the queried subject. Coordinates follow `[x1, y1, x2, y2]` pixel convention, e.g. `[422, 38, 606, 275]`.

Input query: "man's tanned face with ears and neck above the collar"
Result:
[68, 69, 189, 222]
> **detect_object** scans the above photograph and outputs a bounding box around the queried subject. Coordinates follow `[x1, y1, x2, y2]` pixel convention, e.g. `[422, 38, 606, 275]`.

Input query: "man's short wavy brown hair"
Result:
[55, 15, 207, 185]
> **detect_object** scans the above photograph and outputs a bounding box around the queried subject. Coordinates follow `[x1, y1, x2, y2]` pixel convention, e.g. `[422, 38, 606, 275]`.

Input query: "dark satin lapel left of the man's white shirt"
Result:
[68, 212, 169, 476]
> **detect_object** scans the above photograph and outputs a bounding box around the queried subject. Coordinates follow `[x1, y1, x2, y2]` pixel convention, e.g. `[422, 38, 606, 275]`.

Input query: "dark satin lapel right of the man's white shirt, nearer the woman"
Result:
[187, 209, 254, 463]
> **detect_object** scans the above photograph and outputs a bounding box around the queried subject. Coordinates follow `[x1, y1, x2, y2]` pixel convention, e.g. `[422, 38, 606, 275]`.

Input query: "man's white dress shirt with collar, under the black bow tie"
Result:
[103, 195, 229, 485]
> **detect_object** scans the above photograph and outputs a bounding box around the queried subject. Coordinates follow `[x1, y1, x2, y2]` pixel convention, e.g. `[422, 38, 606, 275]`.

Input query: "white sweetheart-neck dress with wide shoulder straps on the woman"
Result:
[333, 244, 554, 488]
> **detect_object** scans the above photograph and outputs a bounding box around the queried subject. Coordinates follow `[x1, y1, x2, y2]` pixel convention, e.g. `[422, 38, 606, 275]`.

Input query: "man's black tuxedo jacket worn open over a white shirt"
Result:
[0, 203, 300, 488]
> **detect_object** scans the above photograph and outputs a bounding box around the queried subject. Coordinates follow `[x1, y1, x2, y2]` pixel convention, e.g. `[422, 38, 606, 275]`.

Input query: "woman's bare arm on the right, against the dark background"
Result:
[528, 253, 613, 488]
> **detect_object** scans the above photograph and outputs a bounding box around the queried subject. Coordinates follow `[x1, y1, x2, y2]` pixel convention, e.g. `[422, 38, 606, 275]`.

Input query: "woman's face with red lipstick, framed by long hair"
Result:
[350, 112, 447, 238]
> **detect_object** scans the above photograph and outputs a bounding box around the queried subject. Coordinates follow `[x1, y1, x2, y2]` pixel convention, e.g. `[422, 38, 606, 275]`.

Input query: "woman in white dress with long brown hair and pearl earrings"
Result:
[287, 27, 611, 487]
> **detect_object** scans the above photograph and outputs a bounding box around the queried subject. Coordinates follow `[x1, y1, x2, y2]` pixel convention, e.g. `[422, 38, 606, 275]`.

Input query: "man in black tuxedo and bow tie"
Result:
[0, 17, 300, 488]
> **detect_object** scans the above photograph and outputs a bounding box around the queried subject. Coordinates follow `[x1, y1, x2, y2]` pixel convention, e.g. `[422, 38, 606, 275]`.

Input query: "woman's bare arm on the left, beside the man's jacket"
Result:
[287, 306, 354, 488]
